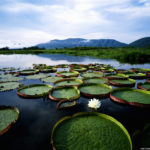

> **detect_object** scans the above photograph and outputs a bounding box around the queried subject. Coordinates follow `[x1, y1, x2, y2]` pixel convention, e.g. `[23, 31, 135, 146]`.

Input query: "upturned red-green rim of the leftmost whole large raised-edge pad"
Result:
[17, 84, 53, 98]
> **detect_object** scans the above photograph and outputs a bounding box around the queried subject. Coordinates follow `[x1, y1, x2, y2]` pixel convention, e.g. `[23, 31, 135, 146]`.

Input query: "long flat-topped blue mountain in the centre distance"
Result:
[37, 38, 127, 49]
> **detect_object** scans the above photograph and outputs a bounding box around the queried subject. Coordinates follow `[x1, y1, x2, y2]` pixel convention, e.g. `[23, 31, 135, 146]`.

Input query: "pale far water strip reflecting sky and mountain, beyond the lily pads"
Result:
[0, 54, 150, 69]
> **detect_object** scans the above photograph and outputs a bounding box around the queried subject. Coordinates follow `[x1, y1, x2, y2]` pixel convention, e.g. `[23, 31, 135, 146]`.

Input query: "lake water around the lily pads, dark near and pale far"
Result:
[0, 54, 150, 150]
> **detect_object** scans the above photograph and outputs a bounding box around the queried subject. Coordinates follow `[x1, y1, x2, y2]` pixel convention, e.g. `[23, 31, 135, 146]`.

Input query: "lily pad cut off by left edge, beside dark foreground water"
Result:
[0, 106, 19, 135]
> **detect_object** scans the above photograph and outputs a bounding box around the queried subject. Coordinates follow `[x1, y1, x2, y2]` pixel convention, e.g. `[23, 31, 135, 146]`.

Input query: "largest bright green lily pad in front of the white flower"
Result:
[51, 113, 132, 150]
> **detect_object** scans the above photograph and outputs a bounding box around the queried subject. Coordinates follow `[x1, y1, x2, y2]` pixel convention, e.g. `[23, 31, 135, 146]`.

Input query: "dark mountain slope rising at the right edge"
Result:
[129, 37, 150, 47]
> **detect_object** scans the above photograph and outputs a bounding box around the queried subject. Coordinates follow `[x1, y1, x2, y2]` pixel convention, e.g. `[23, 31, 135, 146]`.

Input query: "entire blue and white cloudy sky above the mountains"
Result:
[0, 0, 150, 48]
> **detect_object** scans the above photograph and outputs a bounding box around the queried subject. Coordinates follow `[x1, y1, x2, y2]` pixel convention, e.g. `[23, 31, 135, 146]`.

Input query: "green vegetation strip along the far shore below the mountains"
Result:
[0, 46, 150, 64]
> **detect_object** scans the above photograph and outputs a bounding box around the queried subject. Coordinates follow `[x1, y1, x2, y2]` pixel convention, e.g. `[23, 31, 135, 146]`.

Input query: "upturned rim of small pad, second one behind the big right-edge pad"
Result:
[105, 73, 129, 80]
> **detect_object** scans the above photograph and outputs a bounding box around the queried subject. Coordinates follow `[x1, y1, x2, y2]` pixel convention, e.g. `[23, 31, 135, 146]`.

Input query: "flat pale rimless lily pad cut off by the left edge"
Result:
[0, 82, 21, 92]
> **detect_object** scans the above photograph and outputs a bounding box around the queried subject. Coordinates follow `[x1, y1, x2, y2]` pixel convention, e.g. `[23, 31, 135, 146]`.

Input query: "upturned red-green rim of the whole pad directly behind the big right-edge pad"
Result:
[108, 79, 136, 87]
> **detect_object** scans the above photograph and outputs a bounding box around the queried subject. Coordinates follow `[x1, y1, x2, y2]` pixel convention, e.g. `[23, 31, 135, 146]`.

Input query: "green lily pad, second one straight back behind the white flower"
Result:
[83, 77, 108, 84]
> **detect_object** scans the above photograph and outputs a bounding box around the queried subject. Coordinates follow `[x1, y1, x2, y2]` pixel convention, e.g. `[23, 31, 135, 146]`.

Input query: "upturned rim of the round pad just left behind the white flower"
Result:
[48, 86, 80, 101]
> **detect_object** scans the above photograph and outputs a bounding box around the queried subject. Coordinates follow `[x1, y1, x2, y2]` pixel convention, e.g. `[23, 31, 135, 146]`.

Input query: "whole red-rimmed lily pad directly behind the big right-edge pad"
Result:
[108, 79, 136, 87]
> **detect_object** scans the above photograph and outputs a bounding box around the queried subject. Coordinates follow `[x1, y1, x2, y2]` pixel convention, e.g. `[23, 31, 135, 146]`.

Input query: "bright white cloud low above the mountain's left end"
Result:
[0, 29, 64, 48]
